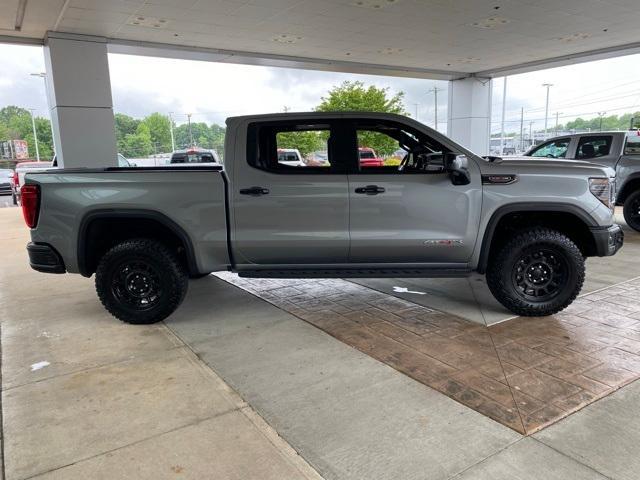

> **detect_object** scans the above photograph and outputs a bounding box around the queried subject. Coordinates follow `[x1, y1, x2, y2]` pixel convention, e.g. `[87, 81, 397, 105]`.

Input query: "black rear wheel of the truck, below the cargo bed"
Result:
[96, 239, 189, 324]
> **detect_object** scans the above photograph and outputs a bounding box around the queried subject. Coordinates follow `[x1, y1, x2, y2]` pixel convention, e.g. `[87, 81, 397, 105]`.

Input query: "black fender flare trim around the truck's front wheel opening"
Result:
[477, 202, 598, 273]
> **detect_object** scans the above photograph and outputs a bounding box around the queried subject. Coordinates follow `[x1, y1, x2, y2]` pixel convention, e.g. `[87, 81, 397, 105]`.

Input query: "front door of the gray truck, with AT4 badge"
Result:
[349, 121, 482, 267]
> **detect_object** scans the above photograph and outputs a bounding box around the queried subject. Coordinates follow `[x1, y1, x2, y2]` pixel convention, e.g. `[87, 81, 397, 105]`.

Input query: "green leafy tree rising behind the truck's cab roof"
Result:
[316, 81, 408, 155]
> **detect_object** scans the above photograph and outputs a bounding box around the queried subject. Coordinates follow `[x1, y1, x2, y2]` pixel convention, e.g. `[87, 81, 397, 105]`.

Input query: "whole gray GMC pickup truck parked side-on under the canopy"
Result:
[22, 112, 623, 323]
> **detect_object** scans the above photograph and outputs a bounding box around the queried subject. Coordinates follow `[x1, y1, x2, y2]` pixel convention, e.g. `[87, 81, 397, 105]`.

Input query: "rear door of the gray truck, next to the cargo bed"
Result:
[231, 119, 350, 267]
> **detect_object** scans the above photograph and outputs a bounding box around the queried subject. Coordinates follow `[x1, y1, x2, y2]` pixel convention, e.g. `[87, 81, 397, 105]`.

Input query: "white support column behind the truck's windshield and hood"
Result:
[447, 77, 492, 155]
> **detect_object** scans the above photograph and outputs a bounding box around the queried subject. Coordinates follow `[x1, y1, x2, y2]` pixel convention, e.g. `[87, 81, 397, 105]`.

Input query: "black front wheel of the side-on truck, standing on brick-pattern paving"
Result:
[487, 228, 585, 317]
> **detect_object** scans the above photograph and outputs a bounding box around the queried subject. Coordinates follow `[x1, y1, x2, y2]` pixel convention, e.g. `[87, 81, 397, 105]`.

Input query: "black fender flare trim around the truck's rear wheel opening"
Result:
[77, 208, 200, 277]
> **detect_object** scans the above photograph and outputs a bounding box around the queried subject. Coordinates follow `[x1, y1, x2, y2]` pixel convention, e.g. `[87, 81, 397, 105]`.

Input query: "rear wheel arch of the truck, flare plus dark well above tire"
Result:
[77, 209, 200, 277]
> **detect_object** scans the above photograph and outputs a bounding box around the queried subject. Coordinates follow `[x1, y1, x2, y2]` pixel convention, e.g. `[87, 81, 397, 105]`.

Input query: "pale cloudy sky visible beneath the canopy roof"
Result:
[0, 44, 640, 131]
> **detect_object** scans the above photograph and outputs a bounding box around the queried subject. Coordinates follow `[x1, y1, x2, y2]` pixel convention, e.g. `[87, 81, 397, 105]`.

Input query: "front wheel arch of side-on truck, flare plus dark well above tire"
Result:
[477, 203, 598, 273]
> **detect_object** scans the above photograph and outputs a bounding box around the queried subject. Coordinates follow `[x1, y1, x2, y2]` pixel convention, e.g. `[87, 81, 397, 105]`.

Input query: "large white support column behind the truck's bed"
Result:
[44, 32, 117, 168]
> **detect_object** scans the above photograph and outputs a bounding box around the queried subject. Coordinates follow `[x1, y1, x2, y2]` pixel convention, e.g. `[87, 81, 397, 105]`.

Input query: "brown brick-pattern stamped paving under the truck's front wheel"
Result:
[218, 273, 640, 434]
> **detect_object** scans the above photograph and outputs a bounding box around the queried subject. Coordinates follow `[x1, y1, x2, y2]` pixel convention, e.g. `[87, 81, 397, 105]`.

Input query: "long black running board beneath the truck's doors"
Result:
[238, 268, 472, 278]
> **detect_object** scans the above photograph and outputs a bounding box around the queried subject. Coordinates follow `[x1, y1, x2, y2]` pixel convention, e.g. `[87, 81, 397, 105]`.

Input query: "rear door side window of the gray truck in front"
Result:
[247, 122, 335, 174]
